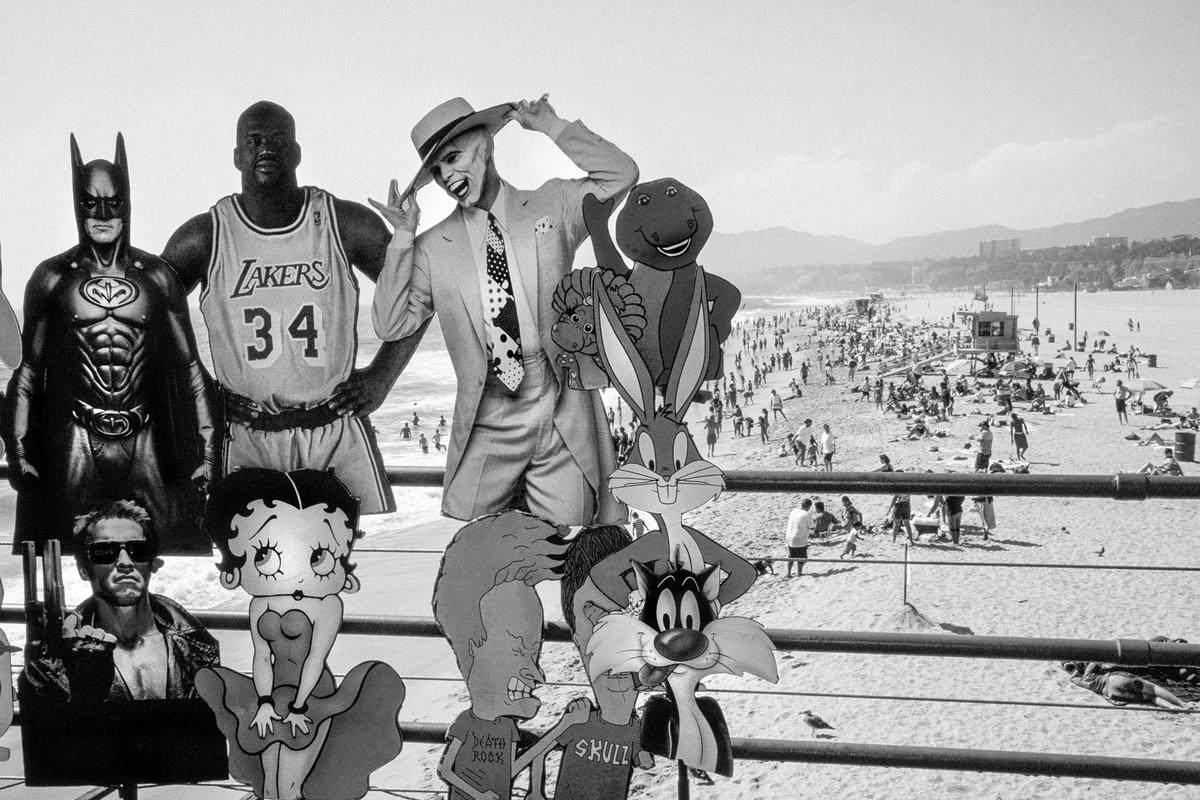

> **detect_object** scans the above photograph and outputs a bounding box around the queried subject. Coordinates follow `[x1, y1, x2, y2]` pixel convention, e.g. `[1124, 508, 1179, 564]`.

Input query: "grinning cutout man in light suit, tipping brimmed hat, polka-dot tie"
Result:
[372, 95, 637, 525]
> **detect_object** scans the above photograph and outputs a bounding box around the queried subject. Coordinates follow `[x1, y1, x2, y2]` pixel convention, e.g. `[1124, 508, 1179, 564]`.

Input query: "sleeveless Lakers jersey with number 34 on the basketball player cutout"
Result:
[200, 186, 359, 413]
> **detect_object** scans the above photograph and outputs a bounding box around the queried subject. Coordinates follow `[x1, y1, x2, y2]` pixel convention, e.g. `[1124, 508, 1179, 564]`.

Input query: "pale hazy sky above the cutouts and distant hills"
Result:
[0, 0, 1200, 287]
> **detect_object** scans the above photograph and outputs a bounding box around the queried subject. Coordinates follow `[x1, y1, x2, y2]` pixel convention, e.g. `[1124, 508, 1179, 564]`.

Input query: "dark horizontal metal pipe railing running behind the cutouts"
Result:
[0, 467, 1200, 796]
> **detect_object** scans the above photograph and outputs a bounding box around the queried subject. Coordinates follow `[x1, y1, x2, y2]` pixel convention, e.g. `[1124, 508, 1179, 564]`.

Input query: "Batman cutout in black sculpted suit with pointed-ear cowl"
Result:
[4, 134, 217, 555]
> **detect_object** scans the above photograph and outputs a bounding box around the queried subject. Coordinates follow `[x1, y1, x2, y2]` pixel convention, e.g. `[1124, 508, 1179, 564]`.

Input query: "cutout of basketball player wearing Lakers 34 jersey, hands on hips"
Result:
[163, 101, 424, 513]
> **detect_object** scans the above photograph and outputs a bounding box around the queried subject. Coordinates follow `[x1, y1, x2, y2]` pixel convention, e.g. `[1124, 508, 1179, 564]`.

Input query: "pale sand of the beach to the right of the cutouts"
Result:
[600, 293, 1200, 798]
